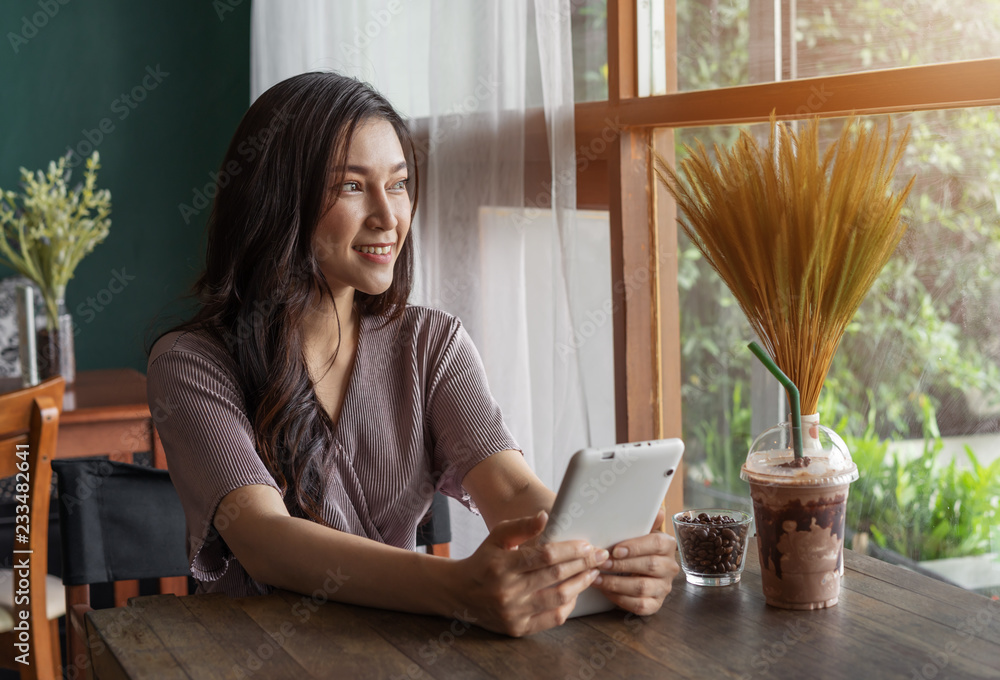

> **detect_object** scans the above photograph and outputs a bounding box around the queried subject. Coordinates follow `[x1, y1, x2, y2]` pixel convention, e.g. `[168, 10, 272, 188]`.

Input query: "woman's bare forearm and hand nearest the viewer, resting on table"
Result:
[216, 485, 607, 636]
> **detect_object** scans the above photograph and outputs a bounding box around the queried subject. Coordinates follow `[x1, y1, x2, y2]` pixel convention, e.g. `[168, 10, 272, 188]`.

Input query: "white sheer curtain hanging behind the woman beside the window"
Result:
[251, 0, 614, 557]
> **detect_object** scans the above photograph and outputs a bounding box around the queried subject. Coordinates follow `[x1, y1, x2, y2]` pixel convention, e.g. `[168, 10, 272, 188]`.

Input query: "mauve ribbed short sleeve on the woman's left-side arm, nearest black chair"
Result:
[146, 336, 278, 582]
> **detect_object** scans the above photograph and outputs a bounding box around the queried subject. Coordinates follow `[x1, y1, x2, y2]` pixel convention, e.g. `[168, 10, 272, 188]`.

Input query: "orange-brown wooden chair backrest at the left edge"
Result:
[0, 377, 66, 677]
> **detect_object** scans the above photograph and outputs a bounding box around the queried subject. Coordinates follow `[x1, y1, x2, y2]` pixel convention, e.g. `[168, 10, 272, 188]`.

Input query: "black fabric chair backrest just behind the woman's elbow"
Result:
[52, 458, 190, 586]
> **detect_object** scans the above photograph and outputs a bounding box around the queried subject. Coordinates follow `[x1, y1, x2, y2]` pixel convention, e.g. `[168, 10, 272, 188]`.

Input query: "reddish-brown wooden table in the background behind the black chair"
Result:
[0, 368, 169, 469]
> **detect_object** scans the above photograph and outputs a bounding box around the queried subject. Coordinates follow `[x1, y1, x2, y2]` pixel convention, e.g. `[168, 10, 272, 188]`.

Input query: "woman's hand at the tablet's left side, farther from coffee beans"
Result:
[456, 511, 609, 637]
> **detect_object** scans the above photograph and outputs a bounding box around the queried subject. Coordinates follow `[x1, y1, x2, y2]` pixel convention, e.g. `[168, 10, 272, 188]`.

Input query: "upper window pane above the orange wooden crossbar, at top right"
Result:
[668, 0, 1000, 94]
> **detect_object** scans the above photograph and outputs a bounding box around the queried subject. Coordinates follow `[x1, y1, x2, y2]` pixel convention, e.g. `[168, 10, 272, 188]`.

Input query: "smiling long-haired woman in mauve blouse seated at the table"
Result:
[148, 73, 678, 636]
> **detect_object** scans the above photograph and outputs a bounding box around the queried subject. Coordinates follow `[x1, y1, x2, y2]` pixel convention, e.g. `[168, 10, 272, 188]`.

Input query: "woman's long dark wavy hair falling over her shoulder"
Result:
[155, 72, 417, 520]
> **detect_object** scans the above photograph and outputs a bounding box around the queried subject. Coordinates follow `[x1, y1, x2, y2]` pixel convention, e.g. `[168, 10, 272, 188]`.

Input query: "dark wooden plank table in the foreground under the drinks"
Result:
[88, 546, 1000, 680]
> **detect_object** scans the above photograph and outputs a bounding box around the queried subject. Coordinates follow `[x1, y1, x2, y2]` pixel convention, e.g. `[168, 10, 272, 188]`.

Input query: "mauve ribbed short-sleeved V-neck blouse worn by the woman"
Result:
[147, 307, 518, 597]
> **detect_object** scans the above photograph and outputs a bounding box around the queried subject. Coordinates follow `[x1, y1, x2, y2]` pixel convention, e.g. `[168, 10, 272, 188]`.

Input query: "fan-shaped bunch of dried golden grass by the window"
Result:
[655, 116, 914, 413]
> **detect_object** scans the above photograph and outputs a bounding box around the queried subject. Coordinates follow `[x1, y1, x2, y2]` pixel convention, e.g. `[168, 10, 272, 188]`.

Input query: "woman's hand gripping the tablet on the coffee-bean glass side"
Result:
[594, 508, 680, 616]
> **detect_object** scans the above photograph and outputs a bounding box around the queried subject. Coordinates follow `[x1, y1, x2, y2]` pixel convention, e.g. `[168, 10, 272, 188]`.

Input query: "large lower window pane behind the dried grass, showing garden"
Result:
[676, 107, 1000, 594]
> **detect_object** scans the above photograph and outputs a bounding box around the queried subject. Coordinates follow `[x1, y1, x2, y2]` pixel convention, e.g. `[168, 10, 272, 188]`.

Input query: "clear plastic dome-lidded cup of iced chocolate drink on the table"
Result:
[740, 414, 858, 609]
